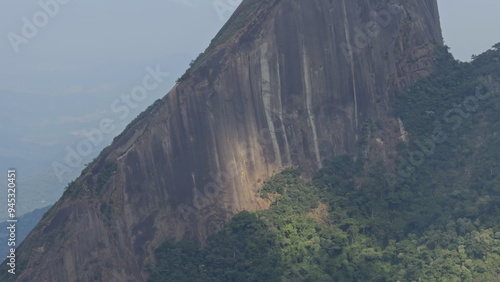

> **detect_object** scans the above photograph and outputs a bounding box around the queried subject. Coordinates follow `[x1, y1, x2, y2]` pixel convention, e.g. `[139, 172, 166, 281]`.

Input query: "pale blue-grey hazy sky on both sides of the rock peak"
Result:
[0, 0, 500, 216]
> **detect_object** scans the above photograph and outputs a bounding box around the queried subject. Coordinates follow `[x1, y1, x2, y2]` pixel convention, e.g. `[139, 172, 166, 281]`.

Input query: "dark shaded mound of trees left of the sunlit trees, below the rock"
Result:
[151, 212, 281, 281]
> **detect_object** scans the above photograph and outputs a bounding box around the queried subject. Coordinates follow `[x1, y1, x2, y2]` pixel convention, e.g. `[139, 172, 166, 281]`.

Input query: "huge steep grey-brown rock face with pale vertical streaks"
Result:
[8, 0, 442, 282]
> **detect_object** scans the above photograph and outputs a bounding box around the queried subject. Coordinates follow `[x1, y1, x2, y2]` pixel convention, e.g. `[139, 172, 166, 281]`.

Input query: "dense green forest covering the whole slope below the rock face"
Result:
[150, 44, 500, 281]
